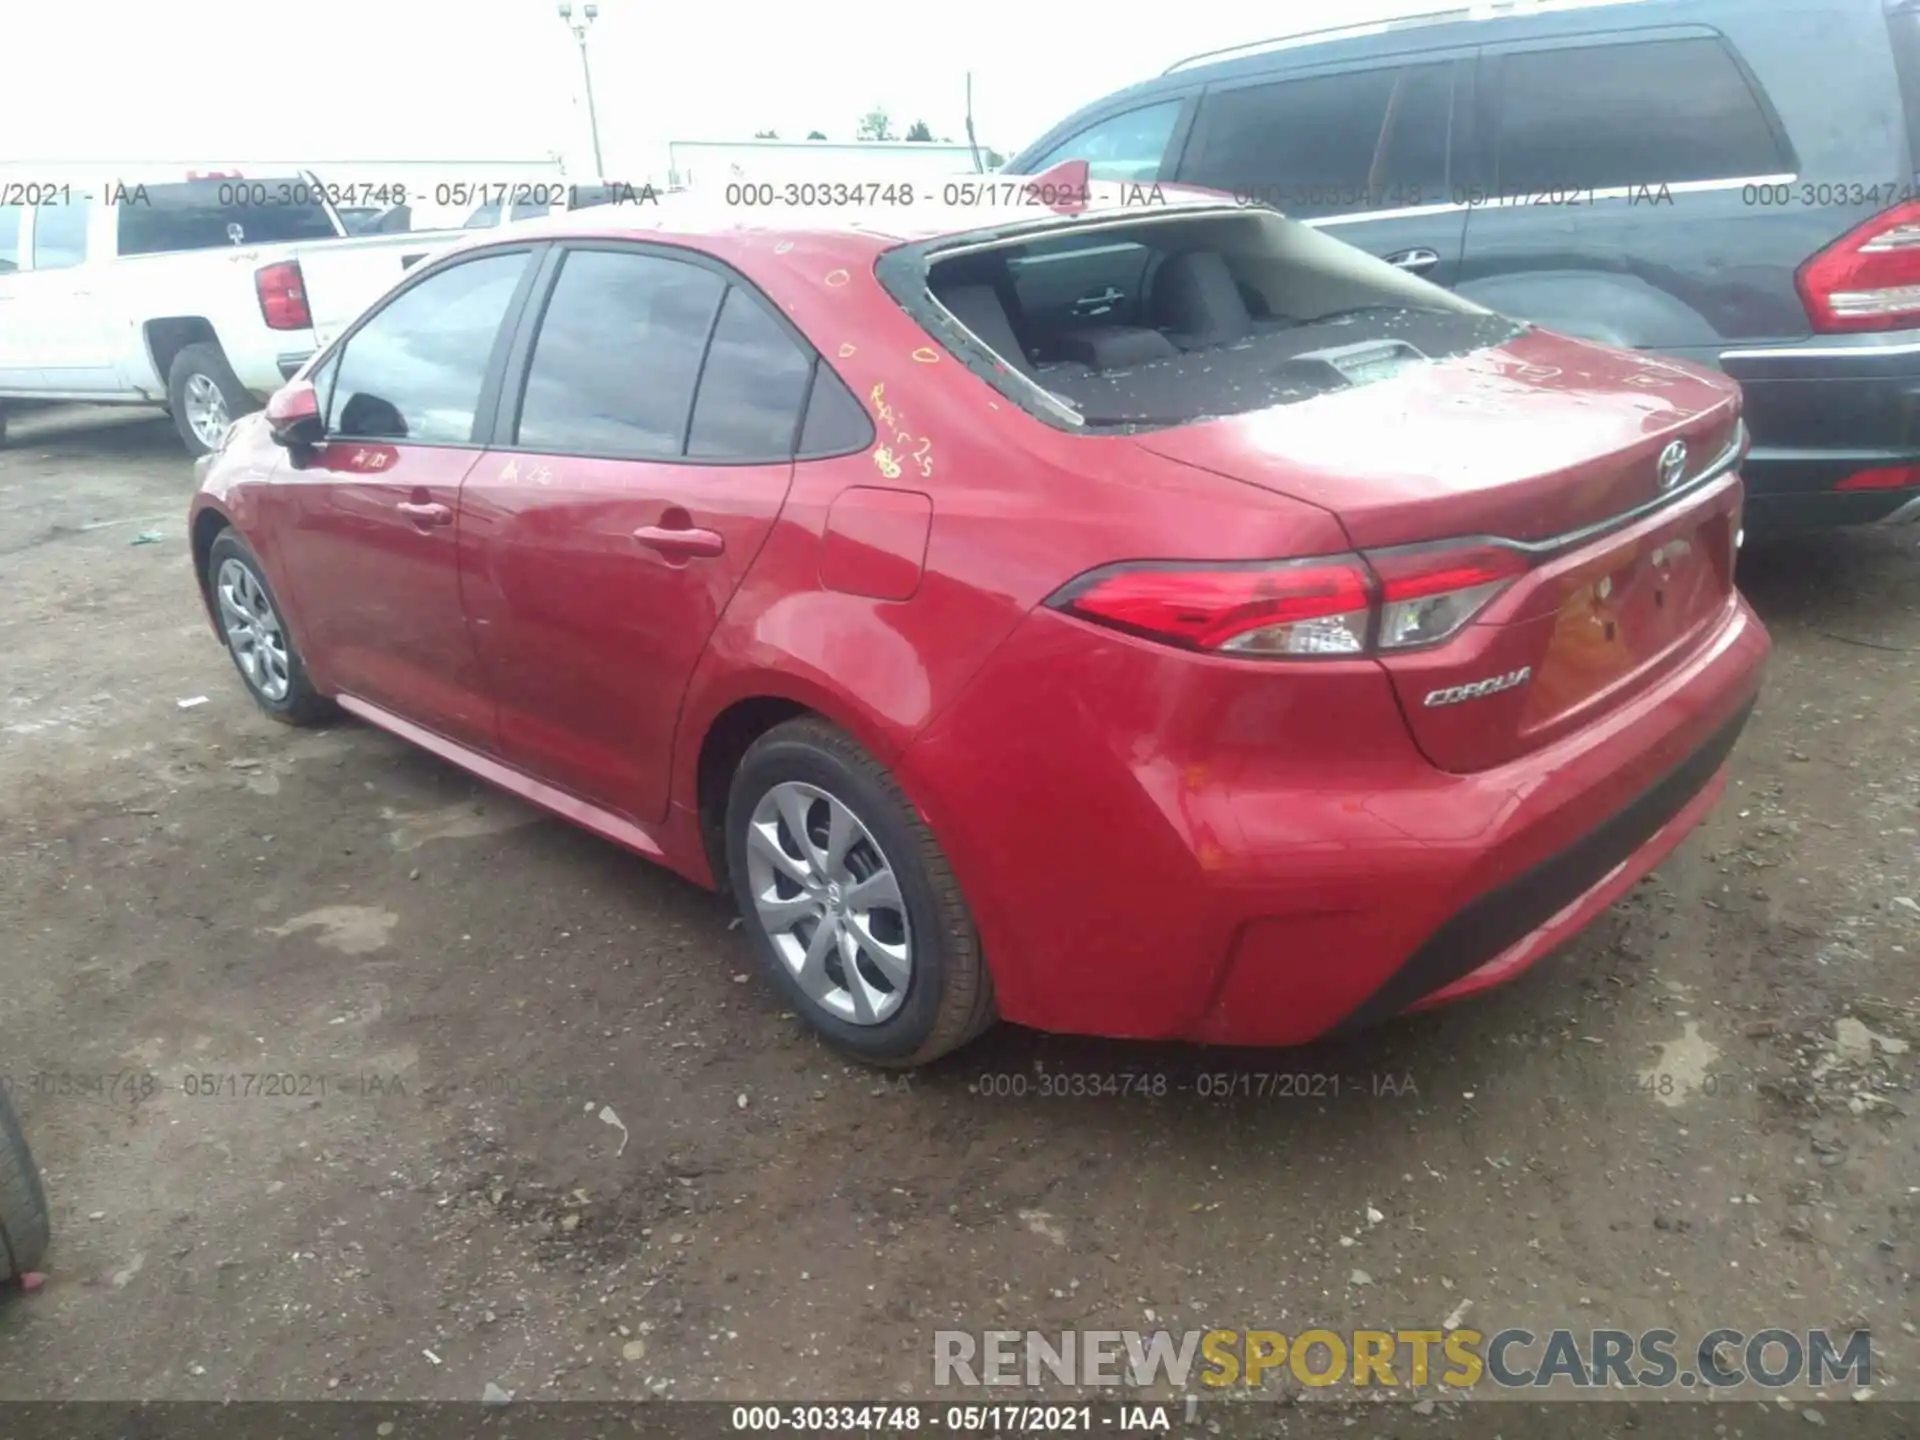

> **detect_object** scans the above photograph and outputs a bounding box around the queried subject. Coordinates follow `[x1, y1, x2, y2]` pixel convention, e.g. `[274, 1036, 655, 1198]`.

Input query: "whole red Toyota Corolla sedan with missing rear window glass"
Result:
[192, 177, 1768, 1064]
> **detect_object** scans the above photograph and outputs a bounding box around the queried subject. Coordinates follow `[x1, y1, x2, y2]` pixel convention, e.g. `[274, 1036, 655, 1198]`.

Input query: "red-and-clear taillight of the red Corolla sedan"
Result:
[1048, 543, 1528, 657]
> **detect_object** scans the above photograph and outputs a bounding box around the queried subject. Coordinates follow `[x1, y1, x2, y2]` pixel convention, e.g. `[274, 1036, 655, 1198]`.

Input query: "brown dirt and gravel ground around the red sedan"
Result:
[0, 403, 1920, 1405]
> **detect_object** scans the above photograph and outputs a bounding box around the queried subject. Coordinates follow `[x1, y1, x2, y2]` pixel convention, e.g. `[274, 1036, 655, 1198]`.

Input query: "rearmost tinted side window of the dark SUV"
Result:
[1496, 36, 1791, 196]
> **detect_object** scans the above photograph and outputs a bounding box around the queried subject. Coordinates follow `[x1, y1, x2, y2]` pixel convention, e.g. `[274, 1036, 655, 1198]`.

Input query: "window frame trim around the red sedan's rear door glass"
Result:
[486, 240, 874, 468]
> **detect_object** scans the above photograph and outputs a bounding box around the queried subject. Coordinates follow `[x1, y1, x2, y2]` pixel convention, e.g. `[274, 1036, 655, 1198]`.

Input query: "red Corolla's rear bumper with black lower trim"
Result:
[900, 597, 1768, 1044]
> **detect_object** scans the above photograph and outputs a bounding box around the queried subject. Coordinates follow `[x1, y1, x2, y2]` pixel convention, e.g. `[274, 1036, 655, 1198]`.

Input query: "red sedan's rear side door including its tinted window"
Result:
[461, 244, 812, 822]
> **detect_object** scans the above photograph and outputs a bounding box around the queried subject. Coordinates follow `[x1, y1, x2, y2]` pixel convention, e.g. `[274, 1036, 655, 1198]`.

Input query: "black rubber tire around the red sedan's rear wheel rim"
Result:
[726, 718, 995, 1069]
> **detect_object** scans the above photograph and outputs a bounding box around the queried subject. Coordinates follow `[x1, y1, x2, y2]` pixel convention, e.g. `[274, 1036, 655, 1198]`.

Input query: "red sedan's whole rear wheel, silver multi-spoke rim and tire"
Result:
[726, 720, 993, 1068]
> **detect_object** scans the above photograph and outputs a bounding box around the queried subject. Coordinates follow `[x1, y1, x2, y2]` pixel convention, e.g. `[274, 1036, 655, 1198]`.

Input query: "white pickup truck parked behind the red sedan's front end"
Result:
[0, 169, 461, 455]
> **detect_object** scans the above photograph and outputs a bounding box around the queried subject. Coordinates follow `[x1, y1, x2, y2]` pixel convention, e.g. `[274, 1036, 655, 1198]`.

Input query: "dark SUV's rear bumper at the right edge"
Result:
[1720, 332, 1920, 530]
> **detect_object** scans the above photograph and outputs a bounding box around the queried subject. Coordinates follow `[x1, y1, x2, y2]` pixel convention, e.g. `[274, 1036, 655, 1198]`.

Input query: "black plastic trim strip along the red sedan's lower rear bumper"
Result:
[1332, 699, 1753, 1035]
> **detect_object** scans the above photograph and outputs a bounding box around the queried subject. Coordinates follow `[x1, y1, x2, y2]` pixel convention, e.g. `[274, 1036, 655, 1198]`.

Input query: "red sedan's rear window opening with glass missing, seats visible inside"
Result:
[881, 209, 1523, 428]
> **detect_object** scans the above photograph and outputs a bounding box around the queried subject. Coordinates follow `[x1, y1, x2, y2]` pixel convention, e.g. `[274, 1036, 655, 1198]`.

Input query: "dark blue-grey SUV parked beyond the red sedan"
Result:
[1006, 0, 1920, 528]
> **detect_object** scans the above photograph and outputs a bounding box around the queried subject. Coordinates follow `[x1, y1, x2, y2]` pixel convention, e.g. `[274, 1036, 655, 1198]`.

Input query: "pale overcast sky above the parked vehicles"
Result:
[0, 0, 1466, 180]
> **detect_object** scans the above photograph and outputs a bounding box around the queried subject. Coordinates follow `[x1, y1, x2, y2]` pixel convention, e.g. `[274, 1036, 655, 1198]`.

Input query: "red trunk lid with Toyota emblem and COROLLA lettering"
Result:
[1135, 332, 1741, 772]
